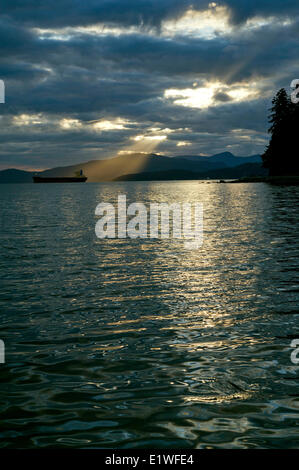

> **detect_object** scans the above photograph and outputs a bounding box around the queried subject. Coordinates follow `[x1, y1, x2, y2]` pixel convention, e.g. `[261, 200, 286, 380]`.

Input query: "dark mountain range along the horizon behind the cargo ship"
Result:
[0, 152, 265, 183]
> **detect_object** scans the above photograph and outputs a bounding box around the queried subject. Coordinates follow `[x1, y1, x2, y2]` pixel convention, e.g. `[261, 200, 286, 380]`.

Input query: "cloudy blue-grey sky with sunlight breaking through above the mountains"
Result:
[0, 0, 299, 170]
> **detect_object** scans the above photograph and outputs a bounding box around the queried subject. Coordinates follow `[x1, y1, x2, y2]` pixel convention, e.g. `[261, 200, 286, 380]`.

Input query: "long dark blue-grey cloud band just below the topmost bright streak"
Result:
[0, 18, 299, 90]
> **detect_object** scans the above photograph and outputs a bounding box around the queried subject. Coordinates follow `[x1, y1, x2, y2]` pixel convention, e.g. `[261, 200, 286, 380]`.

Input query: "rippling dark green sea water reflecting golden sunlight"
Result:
[0, 181, 299, 448]
